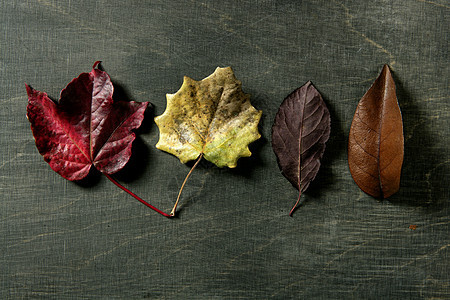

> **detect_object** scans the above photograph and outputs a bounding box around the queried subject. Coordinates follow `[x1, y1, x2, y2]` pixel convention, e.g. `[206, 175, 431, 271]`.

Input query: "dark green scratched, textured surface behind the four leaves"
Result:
[0, 0, 450, 299]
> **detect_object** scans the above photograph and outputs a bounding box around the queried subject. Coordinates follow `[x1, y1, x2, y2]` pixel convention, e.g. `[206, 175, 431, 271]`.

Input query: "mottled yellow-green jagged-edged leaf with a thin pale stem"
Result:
[155, 67, 262, 215]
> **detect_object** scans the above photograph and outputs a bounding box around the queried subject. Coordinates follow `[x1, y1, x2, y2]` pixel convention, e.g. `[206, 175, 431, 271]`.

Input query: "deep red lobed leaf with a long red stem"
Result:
[26, 62, 171, 215]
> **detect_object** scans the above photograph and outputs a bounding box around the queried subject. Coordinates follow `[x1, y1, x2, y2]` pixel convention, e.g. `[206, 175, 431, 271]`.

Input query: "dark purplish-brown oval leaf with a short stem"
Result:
[272, 81, 330, 216]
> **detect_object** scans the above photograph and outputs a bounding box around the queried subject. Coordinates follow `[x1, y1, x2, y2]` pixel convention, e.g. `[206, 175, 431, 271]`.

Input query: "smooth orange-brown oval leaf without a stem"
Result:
[348, 65, 403, 198]
